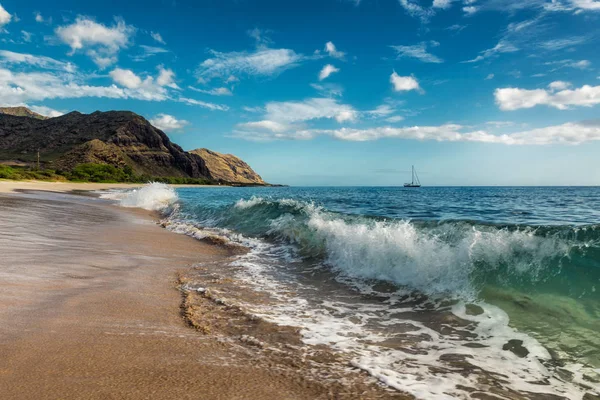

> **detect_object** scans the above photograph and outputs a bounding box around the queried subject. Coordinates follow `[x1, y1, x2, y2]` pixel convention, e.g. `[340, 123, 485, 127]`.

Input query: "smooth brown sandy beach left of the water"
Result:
[0, 188, 403, 399]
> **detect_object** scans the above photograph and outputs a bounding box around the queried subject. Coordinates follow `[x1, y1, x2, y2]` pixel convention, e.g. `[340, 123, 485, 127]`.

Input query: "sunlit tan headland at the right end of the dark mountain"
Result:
[190, 149, 266, 185]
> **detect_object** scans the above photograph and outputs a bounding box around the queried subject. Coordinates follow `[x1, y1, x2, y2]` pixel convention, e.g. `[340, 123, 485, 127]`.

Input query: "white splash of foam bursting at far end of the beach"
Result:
[100, 182, 177, 210]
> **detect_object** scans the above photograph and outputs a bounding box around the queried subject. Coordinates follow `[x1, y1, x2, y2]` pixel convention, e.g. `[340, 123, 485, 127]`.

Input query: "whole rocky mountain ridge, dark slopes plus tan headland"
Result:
[0, 107, 264, 184]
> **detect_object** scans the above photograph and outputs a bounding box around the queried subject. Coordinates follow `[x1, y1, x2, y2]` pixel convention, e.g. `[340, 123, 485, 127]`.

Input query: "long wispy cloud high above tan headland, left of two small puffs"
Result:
[196, 49, 305, 81]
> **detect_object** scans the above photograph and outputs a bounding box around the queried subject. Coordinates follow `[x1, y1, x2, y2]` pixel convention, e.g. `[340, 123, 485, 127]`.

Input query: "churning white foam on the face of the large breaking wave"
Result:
[266, 204, 572, 299]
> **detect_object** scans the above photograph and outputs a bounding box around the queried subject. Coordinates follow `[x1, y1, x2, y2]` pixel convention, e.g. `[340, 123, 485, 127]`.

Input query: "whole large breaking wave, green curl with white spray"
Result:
[173, 197, 600, 300]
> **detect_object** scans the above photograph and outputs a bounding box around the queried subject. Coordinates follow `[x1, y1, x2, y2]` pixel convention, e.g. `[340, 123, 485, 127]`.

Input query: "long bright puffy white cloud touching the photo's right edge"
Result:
[494, 81, 600, 111]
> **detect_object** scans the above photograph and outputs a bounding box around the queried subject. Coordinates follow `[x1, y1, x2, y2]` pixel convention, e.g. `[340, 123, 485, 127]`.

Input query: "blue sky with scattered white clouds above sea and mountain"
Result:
[0, 0, 600, 186]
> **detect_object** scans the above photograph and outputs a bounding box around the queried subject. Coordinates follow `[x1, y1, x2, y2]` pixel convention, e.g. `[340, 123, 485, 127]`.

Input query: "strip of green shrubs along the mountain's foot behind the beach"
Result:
[0, 164, 215, 185]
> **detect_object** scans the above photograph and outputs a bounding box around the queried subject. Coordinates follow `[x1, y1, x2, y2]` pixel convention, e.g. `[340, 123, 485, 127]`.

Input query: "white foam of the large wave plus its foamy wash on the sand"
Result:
[154, 198, 590, 399]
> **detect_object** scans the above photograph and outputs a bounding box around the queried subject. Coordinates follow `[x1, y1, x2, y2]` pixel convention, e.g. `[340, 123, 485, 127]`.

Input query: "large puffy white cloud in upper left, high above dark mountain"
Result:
[55, 16, 135, 68]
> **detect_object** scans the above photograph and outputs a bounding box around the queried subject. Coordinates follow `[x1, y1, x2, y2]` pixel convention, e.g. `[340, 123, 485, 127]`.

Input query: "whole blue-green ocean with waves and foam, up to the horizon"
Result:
[104, 184, 600, 399]
